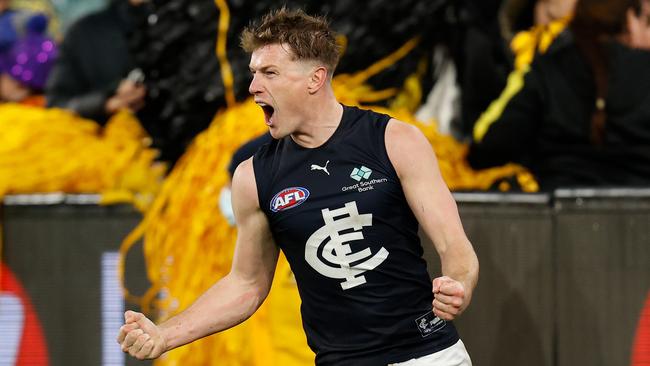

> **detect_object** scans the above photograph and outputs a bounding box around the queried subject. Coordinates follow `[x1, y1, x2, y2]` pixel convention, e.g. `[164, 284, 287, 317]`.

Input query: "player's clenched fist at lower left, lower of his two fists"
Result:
[117, 310, 167, 360]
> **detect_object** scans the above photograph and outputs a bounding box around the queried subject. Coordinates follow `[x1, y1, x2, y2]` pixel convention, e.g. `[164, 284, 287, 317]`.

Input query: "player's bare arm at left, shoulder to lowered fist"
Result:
[118, 159, 279, 359]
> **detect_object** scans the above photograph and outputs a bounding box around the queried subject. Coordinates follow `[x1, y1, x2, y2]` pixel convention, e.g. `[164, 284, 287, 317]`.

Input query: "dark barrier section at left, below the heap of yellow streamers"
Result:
[0, 194, 149, 366]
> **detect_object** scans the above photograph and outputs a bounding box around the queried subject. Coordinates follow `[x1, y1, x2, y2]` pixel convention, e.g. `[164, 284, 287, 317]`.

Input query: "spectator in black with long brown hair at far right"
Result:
[468, 0, 650, 190]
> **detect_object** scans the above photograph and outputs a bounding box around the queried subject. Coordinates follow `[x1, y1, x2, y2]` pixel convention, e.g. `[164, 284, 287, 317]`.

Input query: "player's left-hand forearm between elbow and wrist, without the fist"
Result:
[160, 274, 267, 351]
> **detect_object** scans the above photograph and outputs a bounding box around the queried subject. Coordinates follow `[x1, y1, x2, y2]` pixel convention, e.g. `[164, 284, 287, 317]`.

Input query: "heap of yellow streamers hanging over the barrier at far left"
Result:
[0, 104, 165, 208]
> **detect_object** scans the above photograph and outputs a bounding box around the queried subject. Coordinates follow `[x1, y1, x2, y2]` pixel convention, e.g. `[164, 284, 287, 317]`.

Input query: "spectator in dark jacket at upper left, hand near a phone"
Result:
[46, 0, 146, 124]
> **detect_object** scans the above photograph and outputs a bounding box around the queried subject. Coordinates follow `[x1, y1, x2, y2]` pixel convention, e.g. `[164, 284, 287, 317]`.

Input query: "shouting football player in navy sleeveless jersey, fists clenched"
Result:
[118, 9, 478, 366]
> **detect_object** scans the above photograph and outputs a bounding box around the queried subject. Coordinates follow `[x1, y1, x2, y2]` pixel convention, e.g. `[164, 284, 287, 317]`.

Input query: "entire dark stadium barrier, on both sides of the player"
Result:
[0, 189, 650, 366]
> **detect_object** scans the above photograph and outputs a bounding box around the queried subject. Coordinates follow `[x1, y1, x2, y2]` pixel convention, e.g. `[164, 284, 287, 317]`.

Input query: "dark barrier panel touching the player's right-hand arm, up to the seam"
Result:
[422, 193, 554, 366]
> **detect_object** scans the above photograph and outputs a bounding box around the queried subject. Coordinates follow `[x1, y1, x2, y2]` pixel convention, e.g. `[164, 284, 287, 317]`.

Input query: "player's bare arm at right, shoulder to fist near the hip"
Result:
[386, 119, 479, 320]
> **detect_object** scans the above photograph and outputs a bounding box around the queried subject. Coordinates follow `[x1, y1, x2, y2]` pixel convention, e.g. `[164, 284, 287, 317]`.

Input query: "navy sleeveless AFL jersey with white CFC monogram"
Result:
[253, 106, 458, 366]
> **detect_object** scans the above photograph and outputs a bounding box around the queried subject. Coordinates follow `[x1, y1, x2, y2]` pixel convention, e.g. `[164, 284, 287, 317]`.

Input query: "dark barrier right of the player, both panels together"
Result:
[422, 189, 650, 366]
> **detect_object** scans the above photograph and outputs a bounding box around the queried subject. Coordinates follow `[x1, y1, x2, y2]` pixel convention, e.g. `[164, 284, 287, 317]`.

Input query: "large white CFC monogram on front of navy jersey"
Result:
[305, 202, 388, 290]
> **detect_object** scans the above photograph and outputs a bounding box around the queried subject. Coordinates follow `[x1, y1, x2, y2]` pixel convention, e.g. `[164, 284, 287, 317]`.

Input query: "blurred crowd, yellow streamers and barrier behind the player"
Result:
[0, 0, 650, 366]
